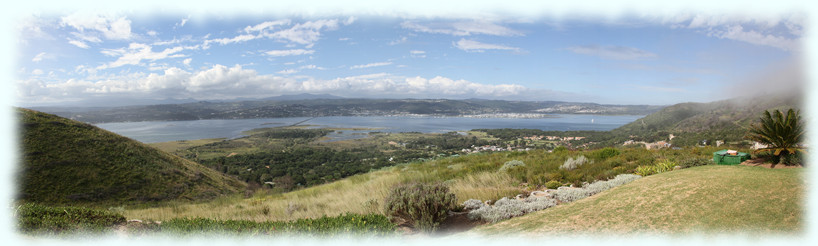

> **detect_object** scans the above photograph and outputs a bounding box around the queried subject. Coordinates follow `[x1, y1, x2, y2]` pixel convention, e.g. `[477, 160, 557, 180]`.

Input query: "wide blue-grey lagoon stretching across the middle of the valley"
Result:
[96, 114, 644, 143]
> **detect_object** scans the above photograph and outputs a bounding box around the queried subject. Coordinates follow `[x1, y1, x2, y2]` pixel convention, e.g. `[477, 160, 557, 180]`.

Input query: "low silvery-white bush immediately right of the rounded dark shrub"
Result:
[463, 197, 557, 223]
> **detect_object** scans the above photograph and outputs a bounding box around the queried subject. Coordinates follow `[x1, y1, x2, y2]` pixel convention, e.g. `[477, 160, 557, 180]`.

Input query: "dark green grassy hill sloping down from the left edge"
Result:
[17, 109, 246, 204]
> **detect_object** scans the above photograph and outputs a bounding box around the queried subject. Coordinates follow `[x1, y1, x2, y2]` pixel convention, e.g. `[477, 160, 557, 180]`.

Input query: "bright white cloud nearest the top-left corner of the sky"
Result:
[60, 13, 133, 40]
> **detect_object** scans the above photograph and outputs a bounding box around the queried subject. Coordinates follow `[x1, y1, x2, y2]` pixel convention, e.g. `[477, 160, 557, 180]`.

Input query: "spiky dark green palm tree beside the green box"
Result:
[747, 109, 804, 163]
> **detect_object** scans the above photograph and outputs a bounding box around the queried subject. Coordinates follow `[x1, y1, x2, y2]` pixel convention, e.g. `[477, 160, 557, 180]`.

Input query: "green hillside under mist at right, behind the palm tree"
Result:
[611, 94, 801, 146]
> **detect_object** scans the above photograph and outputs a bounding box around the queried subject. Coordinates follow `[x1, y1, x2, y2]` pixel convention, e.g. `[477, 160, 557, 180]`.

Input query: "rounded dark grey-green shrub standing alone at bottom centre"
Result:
[384, 183, 456, 232]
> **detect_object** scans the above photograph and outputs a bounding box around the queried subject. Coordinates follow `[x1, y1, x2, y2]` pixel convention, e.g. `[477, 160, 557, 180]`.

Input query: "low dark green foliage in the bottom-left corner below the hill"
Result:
[16, 203, 125, 234]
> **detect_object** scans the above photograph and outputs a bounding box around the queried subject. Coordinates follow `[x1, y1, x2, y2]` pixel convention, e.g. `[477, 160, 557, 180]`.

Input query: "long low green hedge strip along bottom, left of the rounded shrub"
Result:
[161, 213, 396, 236]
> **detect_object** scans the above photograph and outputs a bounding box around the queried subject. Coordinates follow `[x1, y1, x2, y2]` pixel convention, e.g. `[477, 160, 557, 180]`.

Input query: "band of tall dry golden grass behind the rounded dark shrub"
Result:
[124, 165, 519, 221]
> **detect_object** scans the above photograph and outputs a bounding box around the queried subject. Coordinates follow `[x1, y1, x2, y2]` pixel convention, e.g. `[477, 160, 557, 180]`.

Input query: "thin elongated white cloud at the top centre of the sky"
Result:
[401, 21, 524, 36]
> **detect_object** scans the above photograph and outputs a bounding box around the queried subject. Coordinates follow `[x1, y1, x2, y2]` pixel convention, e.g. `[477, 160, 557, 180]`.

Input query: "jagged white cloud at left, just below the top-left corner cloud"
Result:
[97, 43, 193, 69]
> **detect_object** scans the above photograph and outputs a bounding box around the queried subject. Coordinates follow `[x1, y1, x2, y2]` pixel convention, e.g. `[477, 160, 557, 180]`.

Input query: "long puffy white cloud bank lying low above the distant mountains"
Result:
[17, 65, 556, 102]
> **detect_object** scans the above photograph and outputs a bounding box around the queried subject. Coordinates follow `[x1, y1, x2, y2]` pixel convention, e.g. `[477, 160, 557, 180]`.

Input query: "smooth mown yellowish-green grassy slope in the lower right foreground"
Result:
[476, 166, 806, 235]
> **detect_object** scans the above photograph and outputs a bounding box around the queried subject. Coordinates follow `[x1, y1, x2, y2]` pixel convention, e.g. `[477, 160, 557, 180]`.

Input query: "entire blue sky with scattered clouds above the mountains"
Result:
[14, 5, 806, 106]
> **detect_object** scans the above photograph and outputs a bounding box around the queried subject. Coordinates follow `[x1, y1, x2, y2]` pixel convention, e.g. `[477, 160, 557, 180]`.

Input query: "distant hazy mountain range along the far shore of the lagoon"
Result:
[33, 94, 664, 123]
